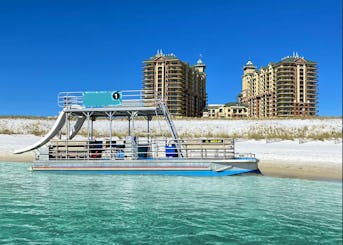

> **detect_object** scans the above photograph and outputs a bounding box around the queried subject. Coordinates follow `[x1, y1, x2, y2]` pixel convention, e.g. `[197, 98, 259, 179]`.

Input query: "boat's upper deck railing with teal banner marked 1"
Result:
[57, 90, 157, 108]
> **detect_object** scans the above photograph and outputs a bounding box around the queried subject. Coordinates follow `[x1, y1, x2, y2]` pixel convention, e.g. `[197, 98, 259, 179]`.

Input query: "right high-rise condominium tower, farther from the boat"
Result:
[239, 54, 318, 118]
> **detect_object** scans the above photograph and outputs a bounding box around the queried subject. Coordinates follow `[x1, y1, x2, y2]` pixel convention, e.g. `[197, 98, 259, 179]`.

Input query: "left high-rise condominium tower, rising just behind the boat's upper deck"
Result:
[143, 50, 206, 117]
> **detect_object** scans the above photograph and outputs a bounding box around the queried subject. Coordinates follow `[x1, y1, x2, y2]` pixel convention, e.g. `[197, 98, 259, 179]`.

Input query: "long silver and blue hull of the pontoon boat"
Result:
[31, 158, 259, 176]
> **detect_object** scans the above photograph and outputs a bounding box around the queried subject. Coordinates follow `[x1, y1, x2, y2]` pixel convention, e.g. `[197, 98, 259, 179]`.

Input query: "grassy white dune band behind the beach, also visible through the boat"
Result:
[0, 118, 342, 142]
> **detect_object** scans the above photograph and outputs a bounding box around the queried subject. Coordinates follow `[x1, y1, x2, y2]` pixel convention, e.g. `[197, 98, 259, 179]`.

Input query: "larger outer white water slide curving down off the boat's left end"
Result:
[14, 110, 68, 154]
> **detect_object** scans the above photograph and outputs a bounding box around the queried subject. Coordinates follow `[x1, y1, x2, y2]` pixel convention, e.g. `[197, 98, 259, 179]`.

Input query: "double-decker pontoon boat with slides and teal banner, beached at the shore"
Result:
[14, 90, 258, 176]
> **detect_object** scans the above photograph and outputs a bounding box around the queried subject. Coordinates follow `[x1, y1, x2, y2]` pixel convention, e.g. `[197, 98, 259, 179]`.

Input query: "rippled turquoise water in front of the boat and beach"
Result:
[0, 163, 342, 244]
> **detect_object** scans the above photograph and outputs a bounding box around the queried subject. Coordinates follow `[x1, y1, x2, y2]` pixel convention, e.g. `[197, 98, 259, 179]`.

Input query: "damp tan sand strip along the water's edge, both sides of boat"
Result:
[0, 151, 342, 181]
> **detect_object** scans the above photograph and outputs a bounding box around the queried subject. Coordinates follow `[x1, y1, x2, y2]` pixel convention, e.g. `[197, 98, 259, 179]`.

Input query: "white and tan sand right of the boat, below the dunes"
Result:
[236, 141, 342, 180]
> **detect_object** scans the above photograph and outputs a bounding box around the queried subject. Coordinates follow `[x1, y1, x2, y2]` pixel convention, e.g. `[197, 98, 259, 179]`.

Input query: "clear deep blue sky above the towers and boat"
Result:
[0, 0, 342, 116]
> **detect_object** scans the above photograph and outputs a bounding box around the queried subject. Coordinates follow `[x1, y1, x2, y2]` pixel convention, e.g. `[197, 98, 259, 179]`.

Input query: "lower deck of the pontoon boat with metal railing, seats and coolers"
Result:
[47, 137, 241, 160]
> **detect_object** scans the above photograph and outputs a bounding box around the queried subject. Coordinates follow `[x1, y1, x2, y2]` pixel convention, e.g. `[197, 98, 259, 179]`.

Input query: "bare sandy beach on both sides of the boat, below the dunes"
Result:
[0, 134, 342, 180]
